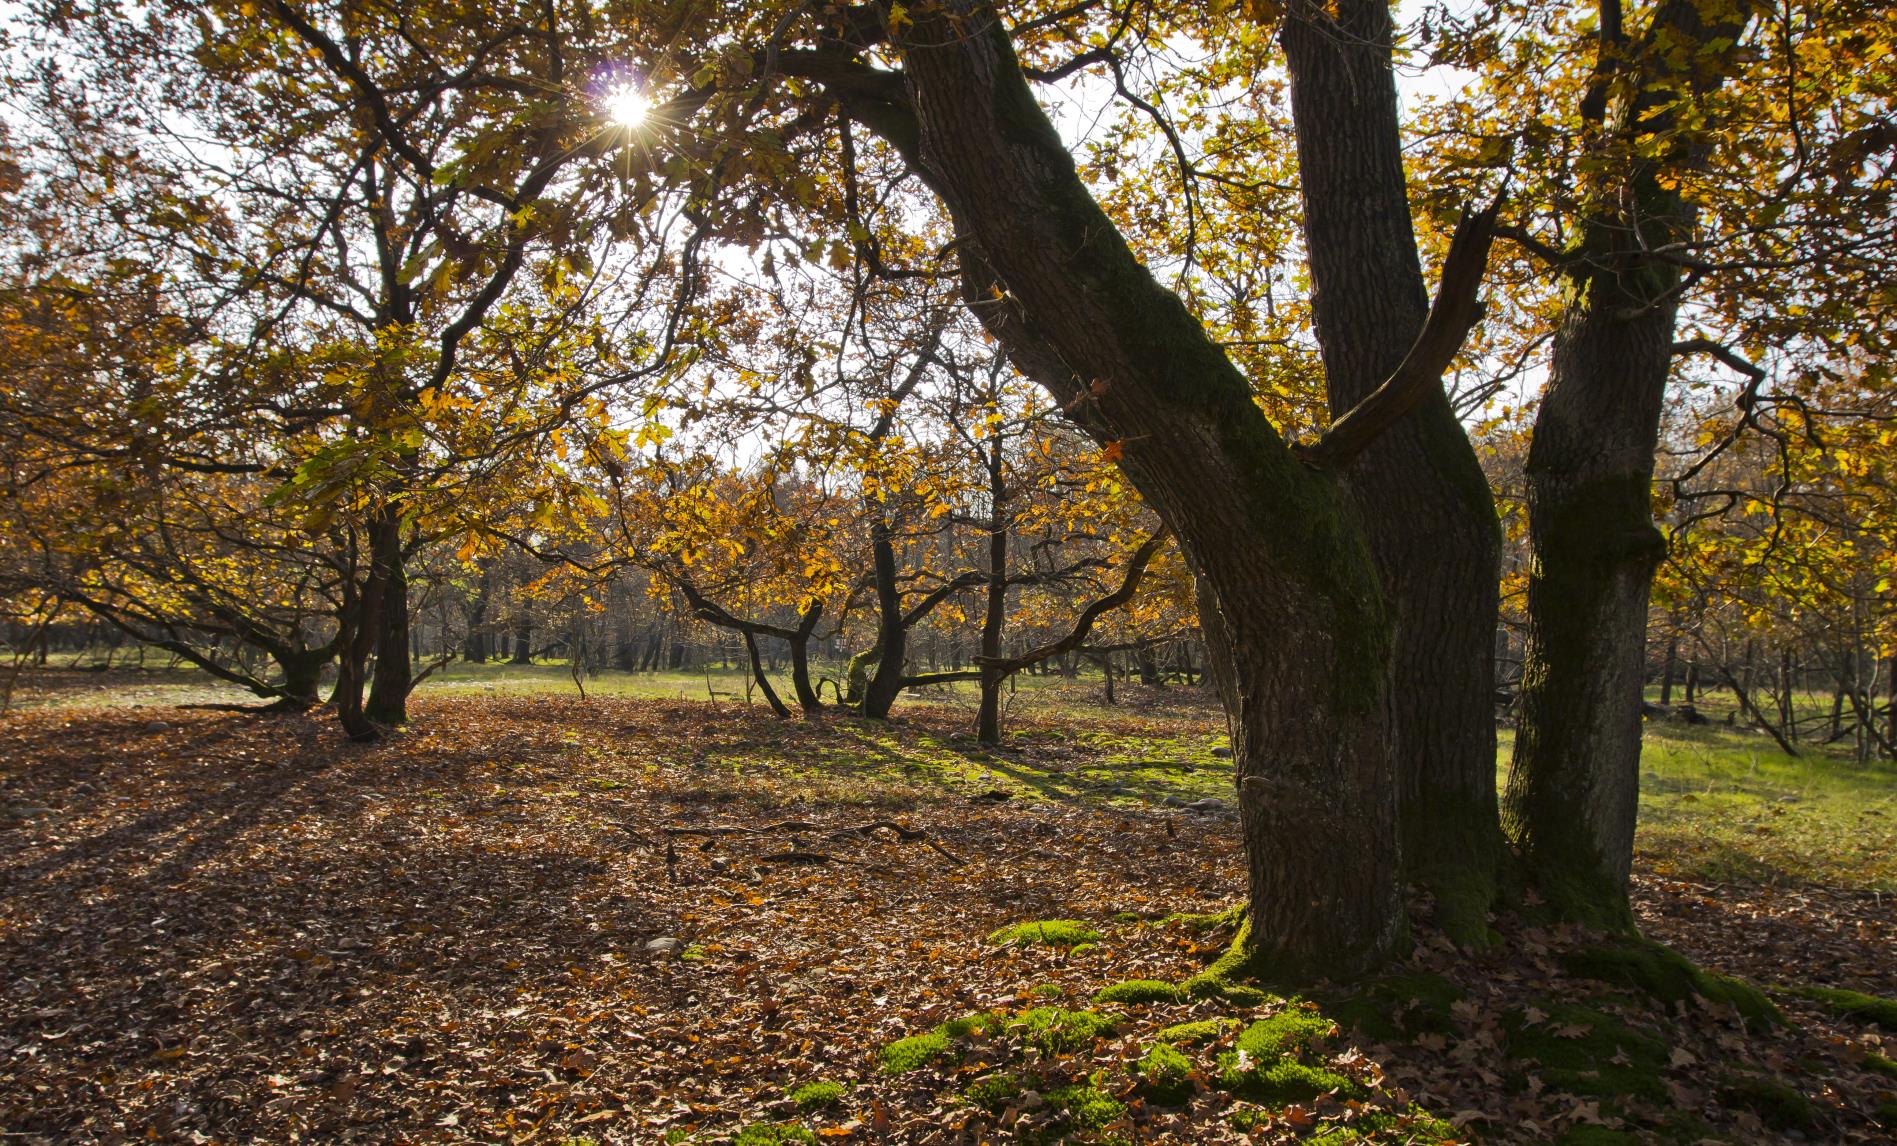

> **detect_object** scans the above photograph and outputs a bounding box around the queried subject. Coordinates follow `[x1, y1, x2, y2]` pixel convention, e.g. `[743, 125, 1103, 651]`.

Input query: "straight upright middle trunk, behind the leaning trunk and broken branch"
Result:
[1280, 0, 1502, 943]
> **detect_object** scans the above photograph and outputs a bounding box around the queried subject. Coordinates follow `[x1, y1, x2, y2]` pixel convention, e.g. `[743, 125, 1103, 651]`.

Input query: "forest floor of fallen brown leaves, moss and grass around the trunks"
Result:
[0, 685, 1897, 1146]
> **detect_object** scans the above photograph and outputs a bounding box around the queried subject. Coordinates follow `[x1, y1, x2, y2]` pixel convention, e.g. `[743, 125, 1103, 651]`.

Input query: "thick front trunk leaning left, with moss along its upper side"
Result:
[833, 0, 1404, 981]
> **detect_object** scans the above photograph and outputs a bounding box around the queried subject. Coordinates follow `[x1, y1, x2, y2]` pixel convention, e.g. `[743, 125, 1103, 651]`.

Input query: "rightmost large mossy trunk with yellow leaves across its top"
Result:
[1502, 0, 1751, 930]
